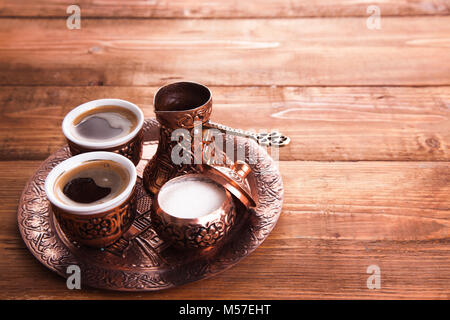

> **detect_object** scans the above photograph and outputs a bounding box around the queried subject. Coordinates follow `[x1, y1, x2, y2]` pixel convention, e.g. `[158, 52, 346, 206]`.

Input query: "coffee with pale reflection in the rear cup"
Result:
[72, 106, 138, 142]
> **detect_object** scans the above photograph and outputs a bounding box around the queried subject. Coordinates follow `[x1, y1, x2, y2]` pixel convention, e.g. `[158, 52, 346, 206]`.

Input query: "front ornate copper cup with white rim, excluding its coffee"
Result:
[45, 152, 137, 248]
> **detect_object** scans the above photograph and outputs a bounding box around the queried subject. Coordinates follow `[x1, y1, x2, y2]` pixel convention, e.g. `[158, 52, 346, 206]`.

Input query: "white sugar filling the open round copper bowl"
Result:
[158, 178, 226, 219]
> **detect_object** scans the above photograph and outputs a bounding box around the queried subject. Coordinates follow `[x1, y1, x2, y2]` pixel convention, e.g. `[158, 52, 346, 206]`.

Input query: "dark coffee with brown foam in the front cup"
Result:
[54, 160, 130, 206]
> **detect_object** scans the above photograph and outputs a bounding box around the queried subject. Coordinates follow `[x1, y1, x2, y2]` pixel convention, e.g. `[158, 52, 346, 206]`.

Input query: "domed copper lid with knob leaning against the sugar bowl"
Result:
[200, 160, 256, 208]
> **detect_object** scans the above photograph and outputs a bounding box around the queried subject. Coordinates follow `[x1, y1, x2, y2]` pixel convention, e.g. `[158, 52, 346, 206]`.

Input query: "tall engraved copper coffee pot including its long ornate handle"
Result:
[143, 82, 290, 194]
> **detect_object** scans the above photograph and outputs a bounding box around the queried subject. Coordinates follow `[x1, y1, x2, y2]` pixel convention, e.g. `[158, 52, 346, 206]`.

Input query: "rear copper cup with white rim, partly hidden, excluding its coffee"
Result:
[62, 99, 144, 165]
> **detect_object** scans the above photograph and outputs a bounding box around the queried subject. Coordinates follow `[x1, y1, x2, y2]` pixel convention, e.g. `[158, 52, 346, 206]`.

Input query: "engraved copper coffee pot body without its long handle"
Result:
[143, 82, 212, 194]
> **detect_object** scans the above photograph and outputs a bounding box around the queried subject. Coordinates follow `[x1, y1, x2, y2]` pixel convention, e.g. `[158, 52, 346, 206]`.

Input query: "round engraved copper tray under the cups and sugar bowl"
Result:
[17, 119, 283, 291]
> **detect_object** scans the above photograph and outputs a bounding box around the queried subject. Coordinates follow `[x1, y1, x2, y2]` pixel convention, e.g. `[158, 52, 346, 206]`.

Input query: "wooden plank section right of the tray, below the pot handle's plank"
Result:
[279, 161, 450, 225]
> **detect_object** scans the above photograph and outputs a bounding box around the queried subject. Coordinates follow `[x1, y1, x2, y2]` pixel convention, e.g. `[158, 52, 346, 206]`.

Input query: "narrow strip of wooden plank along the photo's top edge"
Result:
[0, 0, 450, 18]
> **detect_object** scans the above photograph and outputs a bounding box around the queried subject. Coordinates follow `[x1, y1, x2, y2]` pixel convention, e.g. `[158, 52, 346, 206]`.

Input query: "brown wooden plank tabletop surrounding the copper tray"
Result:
[0, 0, 450, 299]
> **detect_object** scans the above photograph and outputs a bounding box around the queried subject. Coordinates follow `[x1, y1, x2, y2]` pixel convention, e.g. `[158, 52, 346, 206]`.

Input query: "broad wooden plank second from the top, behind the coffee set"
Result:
[0, 16, 450, 86]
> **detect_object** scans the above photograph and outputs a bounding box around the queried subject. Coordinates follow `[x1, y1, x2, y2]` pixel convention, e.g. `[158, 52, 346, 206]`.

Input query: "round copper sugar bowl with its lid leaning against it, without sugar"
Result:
[151, 161, 256, 249]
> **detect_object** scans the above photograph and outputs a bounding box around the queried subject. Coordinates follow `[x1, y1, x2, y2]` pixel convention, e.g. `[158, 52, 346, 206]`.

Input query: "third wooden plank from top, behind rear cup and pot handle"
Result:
[0, 87, 450, 161]
